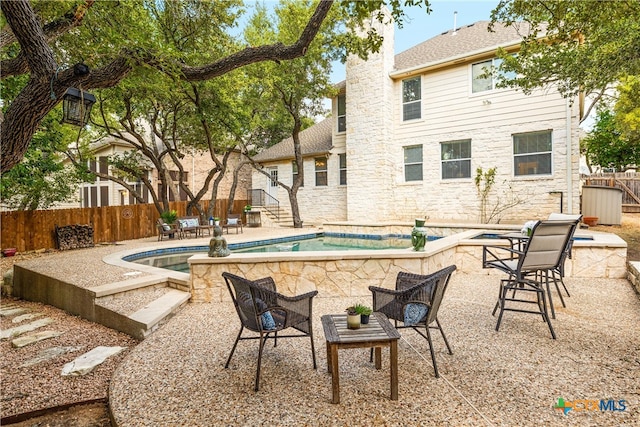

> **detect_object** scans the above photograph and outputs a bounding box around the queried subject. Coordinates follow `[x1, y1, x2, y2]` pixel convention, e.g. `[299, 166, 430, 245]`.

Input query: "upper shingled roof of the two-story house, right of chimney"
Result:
[392, 21, 531, 74]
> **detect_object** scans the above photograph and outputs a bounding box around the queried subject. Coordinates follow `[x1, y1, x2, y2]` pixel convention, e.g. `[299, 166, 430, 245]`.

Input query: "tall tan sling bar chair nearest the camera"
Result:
[482, 220, 576, 339]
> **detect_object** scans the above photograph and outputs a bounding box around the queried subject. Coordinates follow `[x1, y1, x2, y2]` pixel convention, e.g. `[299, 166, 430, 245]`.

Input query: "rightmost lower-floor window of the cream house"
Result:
[513, 130, 552, 176]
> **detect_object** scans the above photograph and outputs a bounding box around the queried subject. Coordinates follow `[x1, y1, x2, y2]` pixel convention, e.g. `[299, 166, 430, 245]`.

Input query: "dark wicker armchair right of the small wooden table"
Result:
[369, 265, 456, 378]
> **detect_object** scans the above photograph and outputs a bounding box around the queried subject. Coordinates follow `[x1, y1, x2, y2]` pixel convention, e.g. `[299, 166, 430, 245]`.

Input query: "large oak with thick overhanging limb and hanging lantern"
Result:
[0, 0, 429, 173]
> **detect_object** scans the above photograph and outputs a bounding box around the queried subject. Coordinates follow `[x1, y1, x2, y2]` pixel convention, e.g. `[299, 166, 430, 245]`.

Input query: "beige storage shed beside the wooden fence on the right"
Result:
[582, 185, 622, 225]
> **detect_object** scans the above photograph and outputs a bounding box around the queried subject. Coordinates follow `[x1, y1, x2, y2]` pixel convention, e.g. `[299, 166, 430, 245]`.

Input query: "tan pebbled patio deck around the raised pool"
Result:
[8, 227, 640, 426]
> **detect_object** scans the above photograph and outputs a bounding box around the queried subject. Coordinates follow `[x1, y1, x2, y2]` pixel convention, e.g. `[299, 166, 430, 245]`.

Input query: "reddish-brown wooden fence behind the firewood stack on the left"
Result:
[0, 199, 247, 252]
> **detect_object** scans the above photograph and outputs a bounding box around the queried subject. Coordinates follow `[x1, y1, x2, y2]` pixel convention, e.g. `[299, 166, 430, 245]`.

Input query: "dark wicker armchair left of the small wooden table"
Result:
[222, 272, 318, 391]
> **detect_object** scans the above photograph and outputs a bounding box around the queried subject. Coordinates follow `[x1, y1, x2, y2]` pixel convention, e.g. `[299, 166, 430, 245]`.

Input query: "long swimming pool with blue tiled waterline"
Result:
[123, 233, 428, 273]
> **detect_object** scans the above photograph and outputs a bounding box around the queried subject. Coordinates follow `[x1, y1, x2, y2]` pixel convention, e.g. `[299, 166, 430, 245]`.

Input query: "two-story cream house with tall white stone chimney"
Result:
[253, 21, 580, 224]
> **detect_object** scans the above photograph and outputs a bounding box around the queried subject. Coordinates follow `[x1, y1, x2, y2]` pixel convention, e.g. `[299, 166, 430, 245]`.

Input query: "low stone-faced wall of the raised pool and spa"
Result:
[189, 226, 627, 302]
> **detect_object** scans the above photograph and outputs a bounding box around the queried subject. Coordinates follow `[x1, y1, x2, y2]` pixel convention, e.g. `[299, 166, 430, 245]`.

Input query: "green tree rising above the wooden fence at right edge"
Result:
[583, 109, 640, 172]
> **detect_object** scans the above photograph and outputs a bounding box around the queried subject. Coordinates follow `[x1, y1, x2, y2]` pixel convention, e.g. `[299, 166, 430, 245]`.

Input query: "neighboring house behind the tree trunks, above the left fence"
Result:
[56, 138, 251, 208]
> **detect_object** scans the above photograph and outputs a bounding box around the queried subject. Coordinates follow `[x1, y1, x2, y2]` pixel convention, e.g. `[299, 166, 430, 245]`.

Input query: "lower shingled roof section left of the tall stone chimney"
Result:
[253, 117, 333, 162]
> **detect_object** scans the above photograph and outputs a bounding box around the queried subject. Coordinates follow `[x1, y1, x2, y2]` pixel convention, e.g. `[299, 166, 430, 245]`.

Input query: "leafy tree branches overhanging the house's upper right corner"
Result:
[491, 0, 640, 118]
